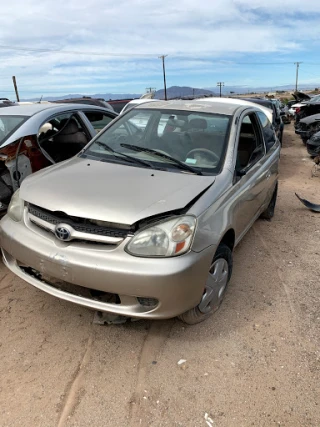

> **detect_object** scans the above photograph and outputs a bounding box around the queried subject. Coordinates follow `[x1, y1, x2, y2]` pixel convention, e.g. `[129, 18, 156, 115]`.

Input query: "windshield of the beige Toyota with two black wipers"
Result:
[82, 109, 231, 175]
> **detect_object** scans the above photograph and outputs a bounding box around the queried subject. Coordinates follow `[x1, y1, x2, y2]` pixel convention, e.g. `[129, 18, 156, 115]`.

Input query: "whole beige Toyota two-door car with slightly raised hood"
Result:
[0, 100, 280, 324]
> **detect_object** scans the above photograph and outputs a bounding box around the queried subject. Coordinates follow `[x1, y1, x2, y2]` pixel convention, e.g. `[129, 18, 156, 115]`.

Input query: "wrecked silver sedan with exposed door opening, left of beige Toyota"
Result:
[0, 104, 117, 213]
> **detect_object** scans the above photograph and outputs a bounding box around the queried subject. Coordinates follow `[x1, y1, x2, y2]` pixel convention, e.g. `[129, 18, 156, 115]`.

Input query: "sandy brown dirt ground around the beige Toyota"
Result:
[0, 125, 320, 427]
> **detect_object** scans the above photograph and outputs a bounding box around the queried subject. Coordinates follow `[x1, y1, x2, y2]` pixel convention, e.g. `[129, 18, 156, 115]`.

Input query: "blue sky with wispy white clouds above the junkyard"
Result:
[0, 0, 320, 98]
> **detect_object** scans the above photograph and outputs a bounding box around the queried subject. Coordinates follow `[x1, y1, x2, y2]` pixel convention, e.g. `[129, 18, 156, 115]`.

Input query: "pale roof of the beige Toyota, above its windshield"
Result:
[136, 98, 272, 121]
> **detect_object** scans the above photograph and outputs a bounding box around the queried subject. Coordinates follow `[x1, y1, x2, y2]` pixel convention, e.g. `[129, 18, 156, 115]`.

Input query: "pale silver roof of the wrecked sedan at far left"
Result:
[1, 103, 113, 117]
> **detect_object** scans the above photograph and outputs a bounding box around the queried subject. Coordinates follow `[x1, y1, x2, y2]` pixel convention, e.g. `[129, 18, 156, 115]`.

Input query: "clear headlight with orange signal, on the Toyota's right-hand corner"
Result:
[126, 216, 196, 257]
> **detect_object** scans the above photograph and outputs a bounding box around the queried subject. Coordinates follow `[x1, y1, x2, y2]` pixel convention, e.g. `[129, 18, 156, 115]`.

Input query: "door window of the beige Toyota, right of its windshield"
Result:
[236, 113, 265, 170]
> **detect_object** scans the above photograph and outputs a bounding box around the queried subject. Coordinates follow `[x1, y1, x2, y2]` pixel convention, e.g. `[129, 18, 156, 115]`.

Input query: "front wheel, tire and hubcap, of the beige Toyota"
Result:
[178, 243, 233, 325]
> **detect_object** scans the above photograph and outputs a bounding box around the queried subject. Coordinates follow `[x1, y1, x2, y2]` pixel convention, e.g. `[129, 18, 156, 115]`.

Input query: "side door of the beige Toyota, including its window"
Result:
[234, 112, 269, 240]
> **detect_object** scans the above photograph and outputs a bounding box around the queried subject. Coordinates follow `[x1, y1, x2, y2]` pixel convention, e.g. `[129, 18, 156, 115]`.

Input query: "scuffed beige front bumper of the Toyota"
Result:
[0, 215, 216, 319]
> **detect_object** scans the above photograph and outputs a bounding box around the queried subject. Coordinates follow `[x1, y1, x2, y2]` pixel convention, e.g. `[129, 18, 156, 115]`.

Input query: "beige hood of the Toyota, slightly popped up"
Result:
[20, 157, 215, 225]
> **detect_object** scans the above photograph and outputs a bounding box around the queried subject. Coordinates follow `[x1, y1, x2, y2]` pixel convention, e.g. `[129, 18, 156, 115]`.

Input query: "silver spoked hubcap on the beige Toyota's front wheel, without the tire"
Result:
[198, 258, 229, 314]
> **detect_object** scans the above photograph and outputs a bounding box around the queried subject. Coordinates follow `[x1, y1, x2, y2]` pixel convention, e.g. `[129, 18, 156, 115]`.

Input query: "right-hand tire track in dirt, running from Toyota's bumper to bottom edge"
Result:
[129, 320, 175, 427]
